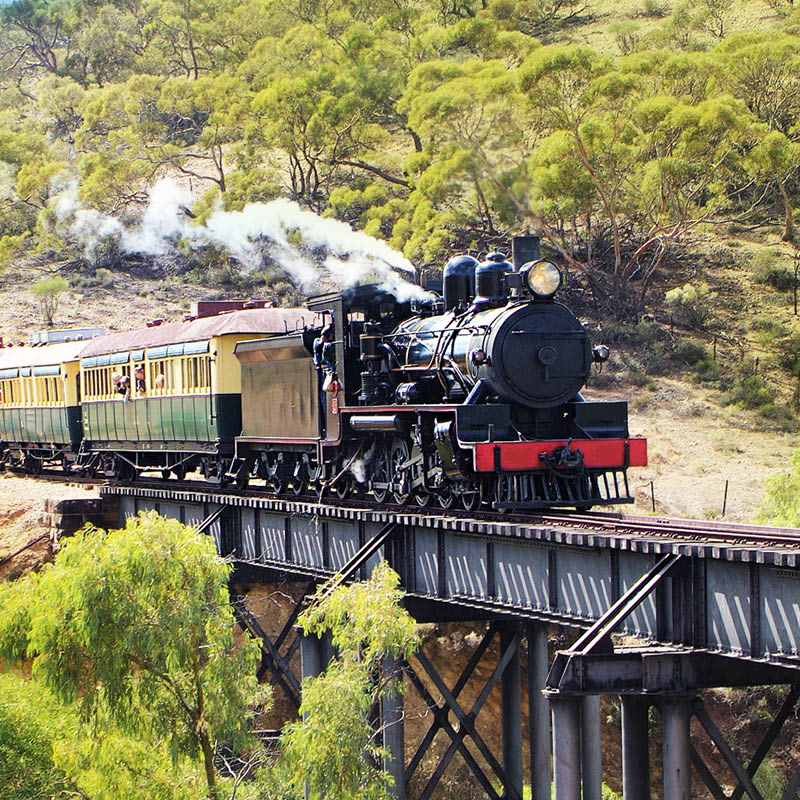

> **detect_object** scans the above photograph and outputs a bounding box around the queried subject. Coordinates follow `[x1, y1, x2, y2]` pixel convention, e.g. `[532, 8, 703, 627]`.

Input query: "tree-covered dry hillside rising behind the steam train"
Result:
[0, 0, 800, 519]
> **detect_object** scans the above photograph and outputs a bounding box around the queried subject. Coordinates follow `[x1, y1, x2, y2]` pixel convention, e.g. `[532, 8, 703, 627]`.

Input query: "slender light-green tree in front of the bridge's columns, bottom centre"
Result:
[278, 562, 419, 800]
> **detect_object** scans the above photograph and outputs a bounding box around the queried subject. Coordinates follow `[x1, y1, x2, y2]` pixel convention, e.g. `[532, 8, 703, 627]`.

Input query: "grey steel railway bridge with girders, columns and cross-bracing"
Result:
[101, 485, 800, 800]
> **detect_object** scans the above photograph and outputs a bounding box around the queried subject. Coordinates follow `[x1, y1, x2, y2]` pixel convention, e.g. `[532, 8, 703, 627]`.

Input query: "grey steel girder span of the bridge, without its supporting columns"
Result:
[101, 485, 800, 666]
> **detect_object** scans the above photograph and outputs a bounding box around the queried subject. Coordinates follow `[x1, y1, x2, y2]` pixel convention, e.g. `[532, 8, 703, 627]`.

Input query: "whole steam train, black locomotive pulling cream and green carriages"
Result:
[0, 237, 646, 510]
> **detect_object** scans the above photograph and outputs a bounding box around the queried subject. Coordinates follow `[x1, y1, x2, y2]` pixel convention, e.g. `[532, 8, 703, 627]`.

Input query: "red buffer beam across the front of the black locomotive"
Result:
[475, 438, 647, 472]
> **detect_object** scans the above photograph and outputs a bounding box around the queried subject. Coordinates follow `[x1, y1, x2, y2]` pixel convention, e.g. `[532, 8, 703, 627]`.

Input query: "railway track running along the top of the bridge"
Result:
[7, 470, 800, 549]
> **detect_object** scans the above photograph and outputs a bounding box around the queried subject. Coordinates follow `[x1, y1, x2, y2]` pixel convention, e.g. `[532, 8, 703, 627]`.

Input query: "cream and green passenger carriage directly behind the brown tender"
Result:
[75, 308, 315, 481]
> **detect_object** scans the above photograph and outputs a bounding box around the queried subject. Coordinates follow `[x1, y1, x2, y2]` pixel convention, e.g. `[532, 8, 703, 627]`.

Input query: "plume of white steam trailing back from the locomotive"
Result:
[56, 179, 425, 300]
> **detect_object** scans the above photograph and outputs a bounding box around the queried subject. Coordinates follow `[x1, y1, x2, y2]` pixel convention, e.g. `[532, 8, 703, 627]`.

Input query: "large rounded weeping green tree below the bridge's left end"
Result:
[0, 513, 258, 798]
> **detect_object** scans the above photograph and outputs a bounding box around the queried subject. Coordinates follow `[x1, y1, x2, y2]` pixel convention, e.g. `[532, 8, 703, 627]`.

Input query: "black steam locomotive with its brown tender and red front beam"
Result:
[230, 237, 647, 510]
